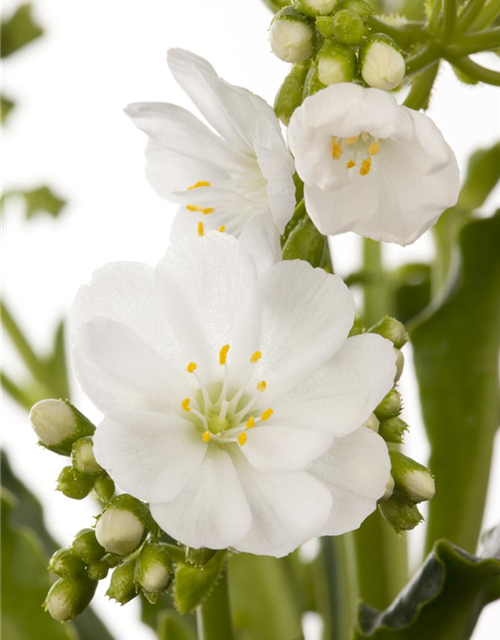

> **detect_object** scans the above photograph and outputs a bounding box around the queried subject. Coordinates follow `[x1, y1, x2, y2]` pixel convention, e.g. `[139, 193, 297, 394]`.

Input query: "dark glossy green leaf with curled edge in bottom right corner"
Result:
[355, 540, 500, 640]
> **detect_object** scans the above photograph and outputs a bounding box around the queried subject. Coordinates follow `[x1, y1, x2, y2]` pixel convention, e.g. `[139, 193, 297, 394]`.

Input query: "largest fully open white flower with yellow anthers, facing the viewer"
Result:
[71, 232, 395, 556]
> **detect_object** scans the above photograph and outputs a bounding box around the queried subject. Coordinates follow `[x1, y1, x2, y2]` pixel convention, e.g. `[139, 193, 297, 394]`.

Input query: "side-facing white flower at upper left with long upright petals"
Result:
[126, 49, 295, 242]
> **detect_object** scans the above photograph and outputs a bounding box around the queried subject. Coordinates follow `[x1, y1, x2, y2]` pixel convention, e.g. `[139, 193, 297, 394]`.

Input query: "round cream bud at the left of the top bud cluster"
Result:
[269, 7, 315, 62]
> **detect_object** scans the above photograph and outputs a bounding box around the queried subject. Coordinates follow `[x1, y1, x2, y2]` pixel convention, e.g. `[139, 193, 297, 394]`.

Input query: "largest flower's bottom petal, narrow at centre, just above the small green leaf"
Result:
[151, 445, 251, 549]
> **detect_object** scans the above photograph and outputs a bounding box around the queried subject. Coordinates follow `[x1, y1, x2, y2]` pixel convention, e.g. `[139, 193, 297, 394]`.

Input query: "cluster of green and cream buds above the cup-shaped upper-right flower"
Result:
[269, 0, 406, 125]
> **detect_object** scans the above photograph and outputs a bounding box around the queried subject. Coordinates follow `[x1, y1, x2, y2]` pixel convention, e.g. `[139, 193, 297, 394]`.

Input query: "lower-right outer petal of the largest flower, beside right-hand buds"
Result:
[309, 427, 391, 536]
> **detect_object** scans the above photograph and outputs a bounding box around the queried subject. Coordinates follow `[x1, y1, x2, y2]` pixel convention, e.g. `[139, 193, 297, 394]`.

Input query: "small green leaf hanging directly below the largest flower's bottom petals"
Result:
[174, 551, 227, 615]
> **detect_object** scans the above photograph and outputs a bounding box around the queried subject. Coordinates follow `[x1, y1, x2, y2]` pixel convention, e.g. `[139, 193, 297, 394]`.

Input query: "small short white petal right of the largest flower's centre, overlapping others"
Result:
[241, 425, 332, 471]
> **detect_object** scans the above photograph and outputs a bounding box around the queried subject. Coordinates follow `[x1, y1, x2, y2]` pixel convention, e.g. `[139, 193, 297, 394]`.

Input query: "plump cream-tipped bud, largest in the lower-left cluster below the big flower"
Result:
[96, 494, 151, 556]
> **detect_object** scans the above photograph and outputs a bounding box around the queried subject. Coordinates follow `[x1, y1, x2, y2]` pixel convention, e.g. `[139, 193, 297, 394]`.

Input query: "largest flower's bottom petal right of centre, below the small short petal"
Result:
[234, 452, 332, 558]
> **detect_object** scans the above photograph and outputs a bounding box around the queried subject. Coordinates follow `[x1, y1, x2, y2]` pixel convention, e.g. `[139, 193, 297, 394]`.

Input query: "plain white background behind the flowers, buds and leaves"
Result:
[2, 0, 500, 640]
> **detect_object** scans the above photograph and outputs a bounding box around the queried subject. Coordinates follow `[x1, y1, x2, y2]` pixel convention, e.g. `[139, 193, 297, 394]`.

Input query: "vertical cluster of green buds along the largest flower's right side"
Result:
[351, 316, 435, 533]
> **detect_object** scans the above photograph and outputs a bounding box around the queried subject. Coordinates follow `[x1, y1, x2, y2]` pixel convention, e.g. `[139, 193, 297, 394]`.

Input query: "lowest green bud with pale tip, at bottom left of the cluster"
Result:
[43, 574, 97, 622]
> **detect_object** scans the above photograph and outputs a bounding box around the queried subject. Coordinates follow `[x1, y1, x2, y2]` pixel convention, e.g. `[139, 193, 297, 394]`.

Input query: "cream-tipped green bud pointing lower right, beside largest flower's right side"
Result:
[389, 451, 436, 503]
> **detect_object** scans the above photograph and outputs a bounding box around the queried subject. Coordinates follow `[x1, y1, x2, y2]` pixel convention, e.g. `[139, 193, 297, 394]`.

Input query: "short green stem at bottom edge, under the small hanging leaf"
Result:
[196, 570, 234, 640]
